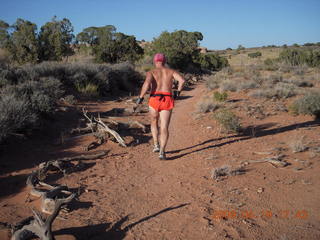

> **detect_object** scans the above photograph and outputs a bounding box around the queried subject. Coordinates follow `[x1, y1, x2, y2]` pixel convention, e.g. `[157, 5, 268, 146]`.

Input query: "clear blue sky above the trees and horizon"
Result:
[0, 0, 320, 49]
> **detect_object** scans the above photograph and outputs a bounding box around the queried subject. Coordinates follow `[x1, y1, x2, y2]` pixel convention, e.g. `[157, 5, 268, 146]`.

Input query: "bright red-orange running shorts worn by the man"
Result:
[149, 92, 174, 112]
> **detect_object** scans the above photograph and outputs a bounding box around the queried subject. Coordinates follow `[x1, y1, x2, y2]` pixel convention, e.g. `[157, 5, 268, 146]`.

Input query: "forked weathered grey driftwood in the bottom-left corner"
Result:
[11, 194, 75, 240]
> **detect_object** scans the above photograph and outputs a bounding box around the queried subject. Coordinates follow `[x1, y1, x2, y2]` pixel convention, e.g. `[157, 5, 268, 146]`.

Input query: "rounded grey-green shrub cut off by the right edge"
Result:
[289, 92, 320, 118]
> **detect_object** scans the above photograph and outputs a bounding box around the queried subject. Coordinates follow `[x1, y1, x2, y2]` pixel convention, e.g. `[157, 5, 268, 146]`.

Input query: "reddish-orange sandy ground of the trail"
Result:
[0, 84, 320, 240]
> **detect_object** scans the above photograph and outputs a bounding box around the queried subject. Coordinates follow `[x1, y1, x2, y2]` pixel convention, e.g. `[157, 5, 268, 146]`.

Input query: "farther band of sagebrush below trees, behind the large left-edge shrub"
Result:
[18, 62, 142, 96]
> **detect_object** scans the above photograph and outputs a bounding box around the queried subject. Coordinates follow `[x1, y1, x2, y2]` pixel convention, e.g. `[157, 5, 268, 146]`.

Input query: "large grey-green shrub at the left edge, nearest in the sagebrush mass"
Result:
[0, 77, 62, 141]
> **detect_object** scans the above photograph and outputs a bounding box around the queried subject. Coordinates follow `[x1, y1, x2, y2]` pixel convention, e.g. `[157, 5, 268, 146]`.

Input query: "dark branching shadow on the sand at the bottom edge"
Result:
[53, 203, 189, 240]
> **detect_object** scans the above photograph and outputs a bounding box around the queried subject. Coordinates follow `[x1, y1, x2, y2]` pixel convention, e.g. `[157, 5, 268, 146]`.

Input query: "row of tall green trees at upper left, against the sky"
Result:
[0, 17, 143, 64]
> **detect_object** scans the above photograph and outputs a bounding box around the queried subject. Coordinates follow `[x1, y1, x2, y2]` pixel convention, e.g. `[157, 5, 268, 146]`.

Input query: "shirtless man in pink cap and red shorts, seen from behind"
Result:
[137, 53, 185, 160]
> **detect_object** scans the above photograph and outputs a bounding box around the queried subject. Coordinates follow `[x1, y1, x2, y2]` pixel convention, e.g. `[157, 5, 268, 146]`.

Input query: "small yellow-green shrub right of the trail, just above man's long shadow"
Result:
[214, 109, 241, 133]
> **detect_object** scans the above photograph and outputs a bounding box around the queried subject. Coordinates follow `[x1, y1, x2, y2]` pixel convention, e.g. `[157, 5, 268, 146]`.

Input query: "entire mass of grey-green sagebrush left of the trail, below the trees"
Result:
[0, 62, 141, 141]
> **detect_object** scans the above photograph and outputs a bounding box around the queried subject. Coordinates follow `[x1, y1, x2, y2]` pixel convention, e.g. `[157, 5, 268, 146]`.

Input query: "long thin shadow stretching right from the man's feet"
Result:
[167, 120, 320, 161]
